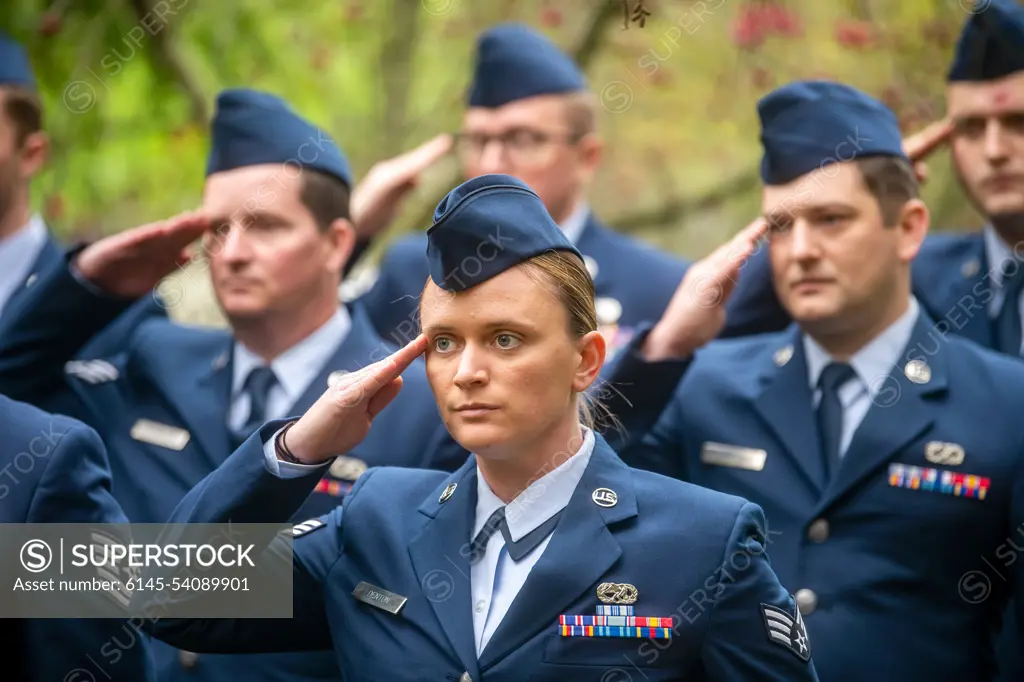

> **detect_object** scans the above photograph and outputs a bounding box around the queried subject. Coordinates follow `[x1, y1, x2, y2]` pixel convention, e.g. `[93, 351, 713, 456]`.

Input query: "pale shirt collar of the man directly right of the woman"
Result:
[802, 296, 921, 398]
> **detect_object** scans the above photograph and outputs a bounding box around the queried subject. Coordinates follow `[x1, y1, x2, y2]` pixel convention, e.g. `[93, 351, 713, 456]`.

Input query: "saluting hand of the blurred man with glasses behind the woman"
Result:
[352, 133, 453, 240]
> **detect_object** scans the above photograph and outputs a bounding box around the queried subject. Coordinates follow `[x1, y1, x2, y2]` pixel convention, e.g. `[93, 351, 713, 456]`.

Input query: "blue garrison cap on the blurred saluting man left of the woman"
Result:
[206, 88, 352, 186]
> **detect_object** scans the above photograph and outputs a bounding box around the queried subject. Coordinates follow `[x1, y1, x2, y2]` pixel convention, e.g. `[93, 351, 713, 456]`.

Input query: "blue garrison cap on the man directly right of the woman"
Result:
[758, 81, 906, 184]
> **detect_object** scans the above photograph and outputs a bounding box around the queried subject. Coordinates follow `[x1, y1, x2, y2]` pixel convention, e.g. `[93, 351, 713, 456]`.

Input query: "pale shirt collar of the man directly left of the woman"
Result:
[231, 305, 352, 404]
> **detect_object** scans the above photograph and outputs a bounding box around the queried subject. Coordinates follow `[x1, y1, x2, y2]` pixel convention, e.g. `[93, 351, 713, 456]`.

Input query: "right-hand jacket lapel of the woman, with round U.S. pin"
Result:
[475, 434, 637, 667]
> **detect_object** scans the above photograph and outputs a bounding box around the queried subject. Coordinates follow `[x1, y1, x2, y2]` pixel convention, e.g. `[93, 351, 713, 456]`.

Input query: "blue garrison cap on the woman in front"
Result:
[427, 174, 583, 292]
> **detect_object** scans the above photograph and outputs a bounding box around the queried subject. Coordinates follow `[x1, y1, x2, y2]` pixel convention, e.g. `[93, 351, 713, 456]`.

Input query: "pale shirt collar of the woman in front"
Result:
[471, 428, 594, 542]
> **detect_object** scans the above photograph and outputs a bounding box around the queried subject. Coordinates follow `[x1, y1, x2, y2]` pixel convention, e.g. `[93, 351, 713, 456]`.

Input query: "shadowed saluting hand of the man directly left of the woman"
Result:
[75, 211, 210, 298]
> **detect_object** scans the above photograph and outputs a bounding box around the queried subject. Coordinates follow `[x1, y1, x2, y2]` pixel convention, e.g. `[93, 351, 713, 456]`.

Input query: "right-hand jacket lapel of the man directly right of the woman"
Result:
[814, 313, 947, 516]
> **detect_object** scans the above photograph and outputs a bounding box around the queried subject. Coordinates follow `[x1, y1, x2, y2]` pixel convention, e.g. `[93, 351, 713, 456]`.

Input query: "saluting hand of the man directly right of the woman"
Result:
[643, 218, 768, 361]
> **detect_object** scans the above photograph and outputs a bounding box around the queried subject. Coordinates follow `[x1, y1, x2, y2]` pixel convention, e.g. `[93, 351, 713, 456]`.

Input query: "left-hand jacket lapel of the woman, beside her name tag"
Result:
[409, 458, 479, 680]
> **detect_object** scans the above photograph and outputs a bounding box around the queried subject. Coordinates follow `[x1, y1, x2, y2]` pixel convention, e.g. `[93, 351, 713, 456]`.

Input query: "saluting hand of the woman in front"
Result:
[285, 334, 427, 464]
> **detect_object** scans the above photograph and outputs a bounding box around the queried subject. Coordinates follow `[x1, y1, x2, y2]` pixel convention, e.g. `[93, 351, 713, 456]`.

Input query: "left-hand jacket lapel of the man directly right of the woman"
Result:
[753, 325, 824, 497]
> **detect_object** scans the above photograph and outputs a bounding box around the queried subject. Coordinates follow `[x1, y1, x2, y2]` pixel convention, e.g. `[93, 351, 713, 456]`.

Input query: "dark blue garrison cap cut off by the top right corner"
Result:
[948, 0, 1024, 82]
